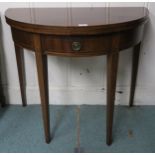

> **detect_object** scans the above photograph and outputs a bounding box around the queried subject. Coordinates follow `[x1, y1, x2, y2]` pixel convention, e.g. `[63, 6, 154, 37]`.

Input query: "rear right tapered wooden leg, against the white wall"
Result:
[129, 43, 141, 107]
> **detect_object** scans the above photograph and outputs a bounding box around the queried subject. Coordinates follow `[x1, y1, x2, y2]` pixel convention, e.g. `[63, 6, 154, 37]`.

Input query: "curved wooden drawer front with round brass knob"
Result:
[42, 35, 110, 56]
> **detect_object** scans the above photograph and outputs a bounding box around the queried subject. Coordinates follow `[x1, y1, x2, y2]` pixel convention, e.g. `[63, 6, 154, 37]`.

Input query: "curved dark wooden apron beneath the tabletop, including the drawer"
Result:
[11, 25, 144, 57]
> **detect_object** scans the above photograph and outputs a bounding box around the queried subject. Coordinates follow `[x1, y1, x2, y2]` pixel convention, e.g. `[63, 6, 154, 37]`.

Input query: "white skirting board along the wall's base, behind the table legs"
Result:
[1, 86, 155, 105]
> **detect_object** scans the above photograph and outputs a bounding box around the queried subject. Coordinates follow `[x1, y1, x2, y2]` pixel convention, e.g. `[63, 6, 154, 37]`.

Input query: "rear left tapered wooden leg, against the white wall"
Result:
[15, 44, 27, 106]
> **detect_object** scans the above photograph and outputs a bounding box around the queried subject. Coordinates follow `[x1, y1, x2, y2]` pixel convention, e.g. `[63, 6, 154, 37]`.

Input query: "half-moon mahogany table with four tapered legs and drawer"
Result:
[5, 7, 148, 145]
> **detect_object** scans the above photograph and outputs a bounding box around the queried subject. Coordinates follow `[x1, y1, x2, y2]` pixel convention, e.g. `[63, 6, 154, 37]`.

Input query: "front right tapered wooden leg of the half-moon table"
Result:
[106, 52, 119, 145]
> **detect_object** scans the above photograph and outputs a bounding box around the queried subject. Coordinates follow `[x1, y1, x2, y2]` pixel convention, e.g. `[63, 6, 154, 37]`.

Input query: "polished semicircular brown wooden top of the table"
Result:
[5, 7, 148, 34]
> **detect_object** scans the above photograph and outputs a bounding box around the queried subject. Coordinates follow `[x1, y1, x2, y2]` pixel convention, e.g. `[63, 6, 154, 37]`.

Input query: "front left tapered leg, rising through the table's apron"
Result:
[34, 34, 50, 143]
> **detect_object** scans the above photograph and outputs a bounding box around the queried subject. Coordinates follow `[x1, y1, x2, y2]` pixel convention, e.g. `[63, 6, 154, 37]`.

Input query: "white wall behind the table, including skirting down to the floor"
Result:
[0, 3, 155, 105]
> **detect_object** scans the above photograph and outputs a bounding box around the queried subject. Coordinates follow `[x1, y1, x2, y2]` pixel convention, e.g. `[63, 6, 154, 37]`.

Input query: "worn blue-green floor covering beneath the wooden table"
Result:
[0, 105, 155, 153]
